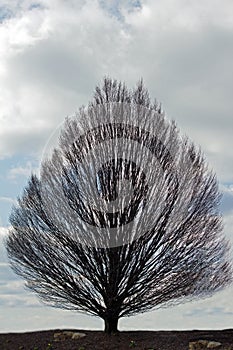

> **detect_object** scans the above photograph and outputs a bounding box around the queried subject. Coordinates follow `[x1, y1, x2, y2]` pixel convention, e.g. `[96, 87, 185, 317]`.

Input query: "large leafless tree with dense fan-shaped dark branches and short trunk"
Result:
[6, 78, 232, 333]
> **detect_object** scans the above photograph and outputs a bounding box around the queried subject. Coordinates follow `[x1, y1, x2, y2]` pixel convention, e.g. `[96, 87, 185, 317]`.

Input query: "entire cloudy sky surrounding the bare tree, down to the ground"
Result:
[0, 0, 233, 332]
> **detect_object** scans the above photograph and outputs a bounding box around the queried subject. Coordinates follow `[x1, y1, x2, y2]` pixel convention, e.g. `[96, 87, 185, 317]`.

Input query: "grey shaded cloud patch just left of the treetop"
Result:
[9, 39, 101, 94]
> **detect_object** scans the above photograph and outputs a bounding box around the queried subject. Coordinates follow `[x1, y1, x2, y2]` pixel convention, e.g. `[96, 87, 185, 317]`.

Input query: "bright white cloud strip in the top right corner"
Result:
[125, 0, 233, 31]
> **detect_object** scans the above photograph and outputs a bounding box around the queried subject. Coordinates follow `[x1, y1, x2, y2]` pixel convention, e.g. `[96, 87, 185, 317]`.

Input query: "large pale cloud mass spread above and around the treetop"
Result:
[0, 0, 233, 181]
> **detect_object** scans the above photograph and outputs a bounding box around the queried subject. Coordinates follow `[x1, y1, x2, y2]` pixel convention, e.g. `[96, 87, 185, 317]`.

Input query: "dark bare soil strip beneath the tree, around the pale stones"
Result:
[0, 329, 233, 350]
